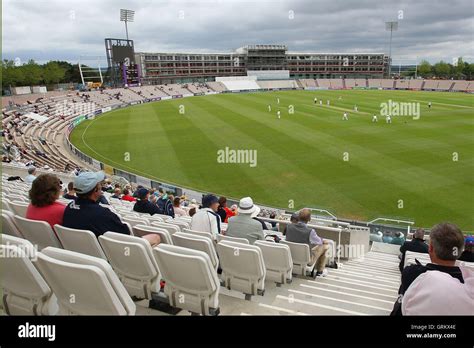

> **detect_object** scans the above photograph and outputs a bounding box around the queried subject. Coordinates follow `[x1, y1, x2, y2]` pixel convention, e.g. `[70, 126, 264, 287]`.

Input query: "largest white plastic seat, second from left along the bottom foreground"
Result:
[34, 247, 136, 315]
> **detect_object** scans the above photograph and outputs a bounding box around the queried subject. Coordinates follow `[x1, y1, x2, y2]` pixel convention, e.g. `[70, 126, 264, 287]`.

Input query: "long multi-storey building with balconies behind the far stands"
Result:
[135, 45, 389, 84]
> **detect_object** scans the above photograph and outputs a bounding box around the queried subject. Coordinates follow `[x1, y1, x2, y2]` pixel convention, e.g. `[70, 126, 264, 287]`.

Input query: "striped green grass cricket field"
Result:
[71, 90, 474, 230]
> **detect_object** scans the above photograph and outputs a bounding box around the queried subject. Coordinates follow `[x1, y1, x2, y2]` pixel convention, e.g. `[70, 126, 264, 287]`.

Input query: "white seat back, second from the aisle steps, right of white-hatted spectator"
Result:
[254, 240, 293, 284]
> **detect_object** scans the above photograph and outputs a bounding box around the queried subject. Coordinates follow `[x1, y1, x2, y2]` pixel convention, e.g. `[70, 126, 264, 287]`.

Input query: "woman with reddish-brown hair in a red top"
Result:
[26, 174, 66, 227]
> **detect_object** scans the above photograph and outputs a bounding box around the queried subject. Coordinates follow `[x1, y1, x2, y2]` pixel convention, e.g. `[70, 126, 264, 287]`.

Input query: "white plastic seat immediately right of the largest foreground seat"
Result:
[99, 232, 160, 299]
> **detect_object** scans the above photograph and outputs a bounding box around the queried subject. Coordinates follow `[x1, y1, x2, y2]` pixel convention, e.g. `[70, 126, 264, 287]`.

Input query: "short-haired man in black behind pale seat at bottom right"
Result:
[391, 222, 464, 315]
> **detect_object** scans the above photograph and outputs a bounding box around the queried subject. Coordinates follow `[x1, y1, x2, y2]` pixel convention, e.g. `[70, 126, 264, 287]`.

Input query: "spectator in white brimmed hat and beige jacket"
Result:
[225, 197, 265, 244]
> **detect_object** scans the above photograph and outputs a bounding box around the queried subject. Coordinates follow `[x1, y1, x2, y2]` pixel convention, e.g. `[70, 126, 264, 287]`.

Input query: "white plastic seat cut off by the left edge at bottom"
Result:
[0, 245, 58, 315]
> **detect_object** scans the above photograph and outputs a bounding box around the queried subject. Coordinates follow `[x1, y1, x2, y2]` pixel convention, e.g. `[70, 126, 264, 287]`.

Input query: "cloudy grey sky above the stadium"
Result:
[2, 0, 474, 64]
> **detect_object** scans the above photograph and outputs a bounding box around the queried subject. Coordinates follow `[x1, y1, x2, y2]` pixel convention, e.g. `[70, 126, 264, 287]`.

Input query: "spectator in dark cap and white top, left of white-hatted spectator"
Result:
[191, 194, 221, 238]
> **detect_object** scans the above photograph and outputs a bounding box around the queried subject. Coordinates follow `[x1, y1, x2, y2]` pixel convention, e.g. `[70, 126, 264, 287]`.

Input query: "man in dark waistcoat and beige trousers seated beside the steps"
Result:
[286, 209, 329, 277]
